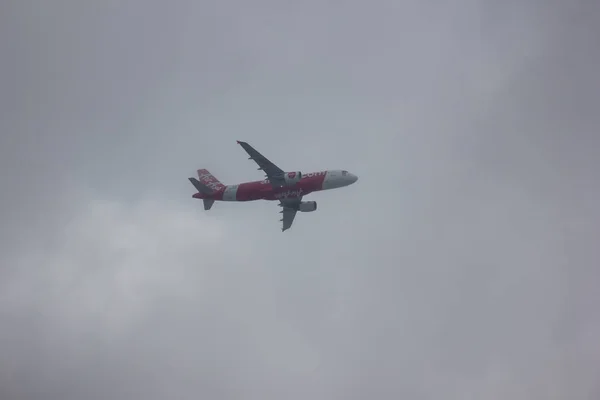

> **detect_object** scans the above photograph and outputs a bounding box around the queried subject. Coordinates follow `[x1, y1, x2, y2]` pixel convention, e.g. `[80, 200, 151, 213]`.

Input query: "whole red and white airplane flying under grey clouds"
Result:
[188, 140, 358, 232]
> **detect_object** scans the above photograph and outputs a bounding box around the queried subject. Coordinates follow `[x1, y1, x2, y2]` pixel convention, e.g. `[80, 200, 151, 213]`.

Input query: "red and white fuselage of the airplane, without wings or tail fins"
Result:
[193, 170, 358, 201]
